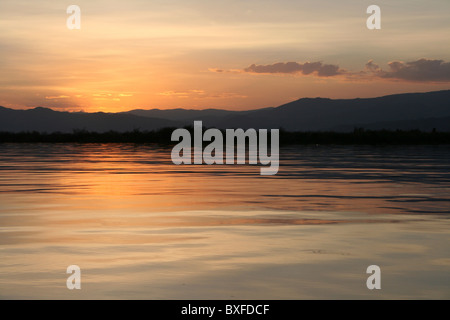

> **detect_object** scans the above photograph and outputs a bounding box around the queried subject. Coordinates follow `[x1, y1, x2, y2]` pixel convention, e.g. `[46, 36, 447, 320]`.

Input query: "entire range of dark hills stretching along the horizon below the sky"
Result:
[0, 90, 450, 132]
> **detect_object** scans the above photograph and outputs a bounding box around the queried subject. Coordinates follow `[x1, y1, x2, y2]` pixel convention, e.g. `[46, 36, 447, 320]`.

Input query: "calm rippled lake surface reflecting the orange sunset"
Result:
[0, 144, 450, 299]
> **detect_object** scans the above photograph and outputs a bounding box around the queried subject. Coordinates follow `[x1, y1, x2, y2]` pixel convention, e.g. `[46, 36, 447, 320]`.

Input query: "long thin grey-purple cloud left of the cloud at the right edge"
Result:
[243, 62, 345, 77]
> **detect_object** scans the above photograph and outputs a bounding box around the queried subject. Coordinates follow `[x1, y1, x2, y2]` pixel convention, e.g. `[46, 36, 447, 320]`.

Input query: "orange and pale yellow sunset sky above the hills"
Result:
[0, 0, 450, 112]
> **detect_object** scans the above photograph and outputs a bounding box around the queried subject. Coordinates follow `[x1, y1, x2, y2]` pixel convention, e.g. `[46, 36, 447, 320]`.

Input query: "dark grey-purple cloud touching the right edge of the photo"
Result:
[374, 58, 450, 82]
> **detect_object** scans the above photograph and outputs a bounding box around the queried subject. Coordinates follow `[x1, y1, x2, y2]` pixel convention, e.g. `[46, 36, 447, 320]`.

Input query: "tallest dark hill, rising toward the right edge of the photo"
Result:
[202, 90, 450, 131]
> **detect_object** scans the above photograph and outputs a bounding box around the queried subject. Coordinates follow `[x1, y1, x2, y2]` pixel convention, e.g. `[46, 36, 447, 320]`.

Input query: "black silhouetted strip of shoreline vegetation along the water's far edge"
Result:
[0, 127, 450, 145]
